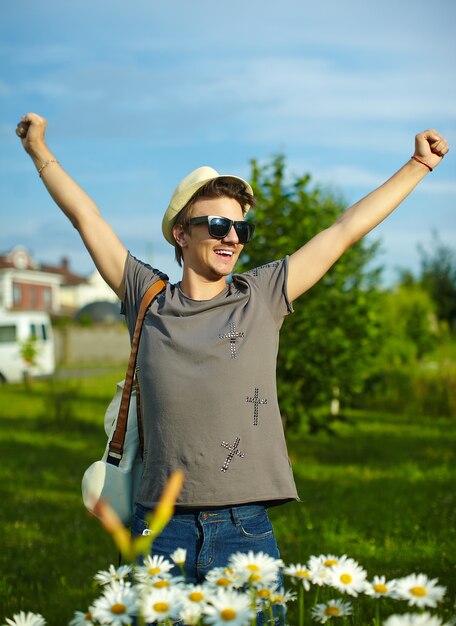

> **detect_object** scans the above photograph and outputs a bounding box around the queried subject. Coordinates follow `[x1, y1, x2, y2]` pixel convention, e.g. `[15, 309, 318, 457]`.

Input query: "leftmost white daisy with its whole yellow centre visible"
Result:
[91, 581, 137, 626]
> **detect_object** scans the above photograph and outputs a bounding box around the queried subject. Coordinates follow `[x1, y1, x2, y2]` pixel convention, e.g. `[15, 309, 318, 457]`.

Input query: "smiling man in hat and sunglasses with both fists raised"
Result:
[16, 113, 448, 600]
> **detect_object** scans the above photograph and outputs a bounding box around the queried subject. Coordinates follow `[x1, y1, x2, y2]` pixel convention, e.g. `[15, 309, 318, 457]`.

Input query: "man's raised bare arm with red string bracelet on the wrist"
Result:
[287, 130, 448, 300]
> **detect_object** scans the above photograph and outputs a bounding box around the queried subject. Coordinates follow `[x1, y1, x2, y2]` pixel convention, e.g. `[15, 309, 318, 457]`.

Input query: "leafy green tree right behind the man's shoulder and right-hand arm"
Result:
[240, 156, 381, 426]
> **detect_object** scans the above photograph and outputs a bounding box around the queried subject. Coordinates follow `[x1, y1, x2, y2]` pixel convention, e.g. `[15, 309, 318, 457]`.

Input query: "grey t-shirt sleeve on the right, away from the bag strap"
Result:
[238, 256, 293, 320]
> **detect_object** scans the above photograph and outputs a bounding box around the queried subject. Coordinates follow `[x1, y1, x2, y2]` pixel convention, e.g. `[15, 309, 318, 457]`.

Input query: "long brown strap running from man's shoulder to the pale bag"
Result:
[106, 279, 166, 465]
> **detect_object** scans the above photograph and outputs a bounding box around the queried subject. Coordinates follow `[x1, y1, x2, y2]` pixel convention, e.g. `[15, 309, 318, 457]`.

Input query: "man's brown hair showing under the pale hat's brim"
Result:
[173, 176, 255, 267]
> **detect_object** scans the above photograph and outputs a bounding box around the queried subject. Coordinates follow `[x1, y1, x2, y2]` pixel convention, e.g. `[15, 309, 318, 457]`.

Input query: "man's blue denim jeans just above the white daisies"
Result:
[131, 504, 283, 625]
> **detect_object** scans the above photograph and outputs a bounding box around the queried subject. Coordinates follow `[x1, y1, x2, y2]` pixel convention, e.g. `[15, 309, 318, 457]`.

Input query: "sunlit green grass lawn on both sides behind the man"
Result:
[0, 369, 456, 626]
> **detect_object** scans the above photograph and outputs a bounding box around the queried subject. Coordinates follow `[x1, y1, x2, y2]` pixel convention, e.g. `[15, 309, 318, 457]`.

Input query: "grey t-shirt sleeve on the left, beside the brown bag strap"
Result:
[121, 252, 168, 336]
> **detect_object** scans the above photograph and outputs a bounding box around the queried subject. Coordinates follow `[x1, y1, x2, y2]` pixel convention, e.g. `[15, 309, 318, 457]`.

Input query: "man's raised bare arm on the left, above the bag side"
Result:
[18, 113, 127, 300]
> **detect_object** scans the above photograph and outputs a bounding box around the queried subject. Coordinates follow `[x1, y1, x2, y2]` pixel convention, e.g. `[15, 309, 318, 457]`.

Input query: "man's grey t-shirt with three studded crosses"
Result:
[123, 254, 298, 508]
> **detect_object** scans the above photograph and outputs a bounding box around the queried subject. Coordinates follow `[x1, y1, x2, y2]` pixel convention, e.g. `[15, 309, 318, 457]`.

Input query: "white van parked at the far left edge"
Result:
[0, 310, 55, 382]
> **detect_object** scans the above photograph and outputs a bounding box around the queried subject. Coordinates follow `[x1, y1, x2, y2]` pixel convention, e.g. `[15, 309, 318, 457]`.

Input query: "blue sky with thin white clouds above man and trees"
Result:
[0, 0, 456, 282]
